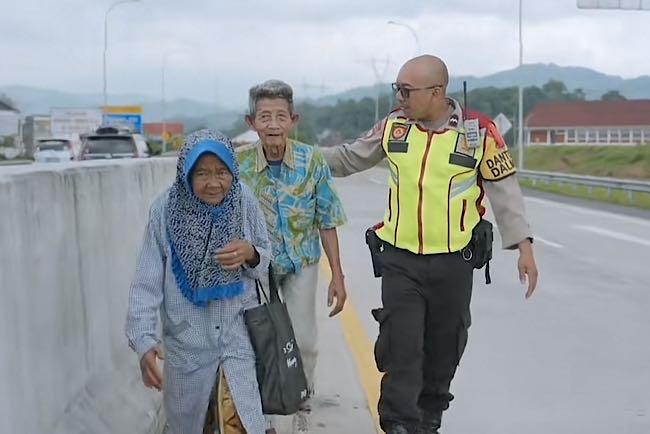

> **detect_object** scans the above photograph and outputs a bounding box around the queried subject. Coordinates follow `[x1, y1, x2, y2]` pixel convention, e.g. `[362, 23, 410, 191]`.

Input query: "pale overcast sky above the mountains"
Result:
[0, 0, 650, 106]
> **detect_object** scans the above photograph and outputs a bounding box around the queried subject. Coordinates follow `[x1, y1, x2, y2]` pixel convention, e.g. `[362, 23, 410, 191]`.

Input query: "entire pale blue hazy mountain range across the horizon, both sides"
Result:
[0, 63, 650, 129]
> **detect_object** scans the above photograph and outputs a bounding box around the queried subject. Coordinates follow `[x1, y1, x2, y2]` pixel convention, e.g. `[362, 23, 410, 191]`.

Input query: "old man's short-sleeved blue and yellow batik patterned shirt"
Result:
[237, 140, 346, 274]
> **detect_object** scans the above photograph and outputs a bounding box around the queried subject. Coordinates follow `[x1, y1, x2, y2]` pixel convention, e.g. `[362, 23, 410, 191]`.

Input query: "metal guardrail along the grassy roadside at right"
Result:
[517, 170, 650, 201]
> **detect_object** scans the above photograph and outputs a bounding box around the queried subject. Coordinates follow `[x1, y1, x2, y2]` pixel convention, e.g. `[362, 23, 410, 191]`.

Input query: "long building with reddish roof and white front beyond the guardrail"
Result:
[524, 99, 650, 145]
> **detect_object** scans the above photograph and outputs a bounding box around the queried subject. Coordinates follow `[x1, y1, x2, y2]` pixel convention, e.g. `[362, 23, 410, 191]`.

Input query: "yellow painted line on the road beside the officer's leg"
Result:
[320, 258, 383, 433]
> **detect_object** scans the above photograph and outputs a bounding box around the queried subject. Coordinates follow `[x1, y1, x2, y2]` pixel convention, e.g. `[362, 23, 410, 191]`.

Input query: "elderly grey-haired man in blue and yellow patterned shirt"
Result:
[233, 80, 346, 432]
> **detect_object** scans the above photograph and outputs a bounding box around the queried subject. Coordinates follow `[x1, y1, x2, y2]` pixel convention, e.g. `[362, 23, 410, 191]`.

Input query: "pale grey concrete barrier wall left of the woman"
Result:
[0, 158, 176, 434]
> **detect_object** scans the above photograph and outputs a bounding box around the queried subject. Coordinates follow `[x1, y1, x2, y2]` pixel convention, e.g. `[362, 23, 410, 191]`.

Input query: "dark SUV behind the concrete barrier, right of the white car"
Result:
[81, 127, 149, 160]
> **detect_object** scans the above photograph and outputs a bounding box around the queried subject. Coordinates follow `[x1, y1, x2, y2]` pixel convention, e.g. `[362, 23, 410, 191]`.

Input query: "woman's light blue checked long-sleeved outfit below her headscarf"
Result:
[126, 185, 271, 434]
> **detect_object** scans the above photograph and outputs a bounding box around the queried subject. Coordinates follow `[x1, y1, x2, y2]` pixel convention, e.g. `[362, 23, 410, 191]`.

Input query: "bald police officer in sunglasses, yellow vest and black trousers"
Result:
[322, 55, 538, 434]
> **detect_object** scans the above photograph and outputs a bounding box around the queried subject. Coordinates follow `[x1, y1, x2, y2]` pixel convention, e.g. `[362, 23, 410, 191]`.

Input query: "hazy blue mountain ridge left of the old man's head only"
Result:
[0, 86, 241, 128]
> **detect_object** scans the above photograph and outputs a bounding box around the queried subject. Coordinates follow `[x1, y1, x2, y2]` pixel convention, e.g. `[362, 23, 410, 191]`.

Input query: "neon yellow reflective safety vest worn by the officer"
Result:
[377, 117, 484, 254]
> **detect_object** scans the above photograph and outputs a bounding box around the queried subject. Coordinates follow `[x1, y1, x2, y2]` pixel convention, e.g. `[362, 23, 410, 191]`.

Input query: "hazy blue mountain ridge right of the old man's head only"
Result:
[311, 63, 650, 105]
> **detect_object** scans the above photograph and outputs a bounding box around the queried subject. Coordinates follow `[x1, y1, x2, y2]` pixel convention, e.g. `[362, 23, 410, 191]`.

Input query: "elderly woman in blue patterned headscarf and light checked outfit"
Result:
[126, 130, 270, 434]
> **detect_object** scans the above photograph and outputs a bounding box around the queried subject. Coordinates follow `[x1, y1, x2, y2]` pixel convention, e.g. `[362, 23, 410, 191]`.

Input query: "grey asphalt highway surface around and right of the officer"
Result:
[326, 169, 650, 434]
